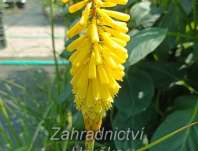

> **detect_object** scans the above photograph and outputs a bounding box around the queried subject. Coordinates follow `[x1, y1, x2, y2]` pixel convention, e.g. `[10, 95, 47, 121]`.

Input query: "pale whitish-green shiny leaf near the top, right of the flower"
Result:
[130, 1, 161, 27]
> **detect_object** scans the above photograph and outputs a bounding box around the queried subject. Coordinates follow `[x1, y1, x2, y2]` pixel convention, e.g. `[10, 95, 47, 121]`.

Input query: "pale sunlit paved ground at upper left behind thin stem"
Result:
[0, 0, 65, 59]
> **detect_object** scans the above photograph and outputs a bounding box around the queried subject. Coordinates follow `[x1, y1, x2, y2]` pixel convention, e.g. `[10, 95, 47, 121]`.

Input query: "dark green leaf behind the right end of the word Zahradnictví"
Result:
[112, 106, 157, 151]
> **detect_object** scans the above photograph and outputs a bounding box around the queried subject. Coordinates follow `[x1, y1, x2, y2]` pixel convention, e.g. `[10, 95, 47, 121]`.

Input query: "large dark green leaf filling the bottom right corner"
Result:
[150, 97, 198, 151]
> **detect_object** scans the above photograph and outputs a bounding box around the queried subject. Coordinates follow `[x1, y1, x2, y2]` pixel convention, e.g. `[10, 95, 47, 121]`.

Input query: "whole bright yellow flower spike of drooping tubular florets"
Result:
[67, 0, 130, 139]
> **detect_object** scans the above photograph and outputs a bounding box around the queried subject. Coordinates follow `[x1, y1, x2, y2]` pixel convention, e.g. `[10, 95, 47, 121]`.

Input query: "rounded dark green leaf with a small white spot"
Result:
[116, 69, 154, 116]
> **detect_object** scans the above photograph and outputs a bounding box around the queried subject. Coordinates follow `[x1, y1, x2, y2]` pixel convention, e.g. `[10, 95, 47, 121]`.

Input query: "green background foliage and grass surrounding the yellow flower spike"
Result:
[0, 0, 198, 151]
